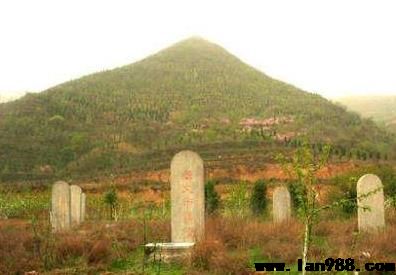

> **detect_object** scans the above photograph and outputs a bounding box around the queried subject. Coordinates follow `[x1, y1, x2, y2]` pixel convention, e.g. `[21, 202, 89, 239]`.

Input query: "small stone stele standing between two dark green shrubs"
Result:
[272, 186, 291, 223]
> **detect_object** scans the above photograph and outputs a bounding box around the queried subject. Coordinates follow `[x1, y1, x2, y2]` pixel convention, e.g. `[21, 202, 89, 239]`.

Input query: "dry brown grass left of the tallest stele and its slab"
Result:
[0, 220, 170, 274]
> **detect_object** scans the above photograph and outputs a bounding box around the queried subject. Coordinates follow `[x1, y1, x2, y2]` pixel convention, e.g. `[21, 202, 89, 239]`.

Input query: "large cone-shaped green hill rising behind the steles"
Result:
[0, 38, 394, 181]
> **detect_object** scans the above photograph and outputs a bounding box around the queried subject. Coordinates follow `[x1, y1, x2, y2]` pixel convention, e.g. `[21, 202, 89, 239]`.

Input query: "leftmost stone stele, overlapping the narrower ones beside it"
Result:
[50, 181, 71, 232]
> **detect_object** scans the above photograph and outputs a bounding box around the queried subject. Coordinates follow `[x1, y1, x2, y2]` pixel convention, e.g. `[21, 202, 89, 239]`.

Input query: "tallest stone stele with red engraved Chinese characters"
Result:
[170, 151, 205, 242]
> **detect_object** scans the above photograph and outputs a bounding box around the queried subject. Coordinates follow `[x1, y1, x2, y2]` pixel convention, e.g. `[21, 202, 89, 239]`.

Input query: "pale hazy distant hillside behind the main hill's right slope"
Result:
[337, 95, 396, 133]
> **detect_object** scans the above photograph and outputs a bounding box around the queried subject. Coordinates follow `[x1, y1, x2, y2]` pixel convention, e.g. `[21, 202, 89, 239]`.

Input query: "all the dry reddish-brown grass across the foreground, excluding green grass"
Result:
[0, 210, 396, 274]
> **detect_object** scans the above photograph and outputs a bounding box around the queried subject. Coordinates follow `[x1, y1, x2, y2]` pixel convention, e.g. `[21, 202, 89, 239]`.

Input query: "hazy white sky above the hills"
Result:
[0, 0, 396, 99]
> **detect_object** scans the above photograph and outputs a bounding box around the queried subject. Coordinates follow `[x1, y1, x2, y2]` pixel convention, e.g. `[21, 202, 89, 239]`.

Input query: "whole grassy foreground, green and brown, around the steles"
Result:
[0, 185, 396, 274]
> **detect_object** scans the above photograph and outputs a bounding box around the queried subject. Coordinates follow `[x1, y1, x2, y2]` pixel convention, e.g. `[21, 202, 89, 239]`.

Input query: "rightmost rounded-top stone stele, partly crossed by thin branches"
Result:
[356, 174, 385, 232]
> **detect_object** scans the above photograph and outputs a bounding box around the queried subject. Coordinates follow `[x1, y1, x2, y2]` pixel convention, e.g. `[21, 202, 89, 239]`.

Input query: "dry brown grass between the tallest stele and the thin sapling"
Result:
[192, 217, 301, 274]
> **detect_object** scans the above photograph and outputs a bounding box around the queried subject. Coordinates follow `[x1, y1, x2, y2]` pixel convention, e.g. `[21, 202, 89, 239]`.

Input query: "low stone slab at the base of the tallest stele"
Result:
[144, 243, 195, 263]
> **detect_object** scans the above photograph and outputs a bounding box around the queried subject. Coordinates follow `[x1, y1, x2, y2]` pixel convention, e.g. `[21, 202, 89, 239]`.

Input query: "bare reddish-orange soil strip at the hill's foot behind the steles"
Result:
[80, 162, 361, 206]
